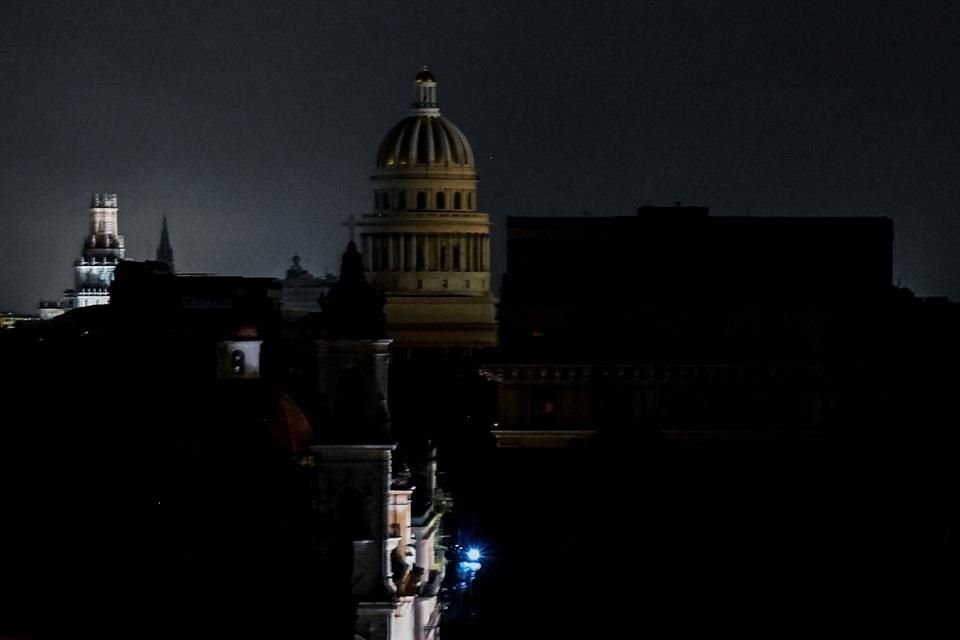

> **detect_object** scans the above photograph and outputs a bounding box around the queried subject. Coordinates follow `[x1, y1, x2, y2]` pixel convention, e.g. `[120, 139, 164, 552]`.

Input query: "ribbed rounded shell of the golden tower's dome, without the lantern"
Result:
[377, 114, 475, 171]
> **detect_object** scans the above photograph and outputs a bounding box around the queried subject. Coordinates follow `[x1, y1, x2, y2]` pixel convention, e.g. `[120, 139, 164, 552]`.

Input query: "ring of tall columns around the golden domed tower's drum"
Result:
[363, 233, 490, 272]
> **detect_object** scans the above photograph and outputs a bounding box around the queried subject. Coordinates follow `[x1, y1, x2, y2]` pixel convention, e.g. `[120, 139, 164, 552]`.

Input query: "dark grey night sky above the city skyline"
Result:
[0, 0, 960, 311]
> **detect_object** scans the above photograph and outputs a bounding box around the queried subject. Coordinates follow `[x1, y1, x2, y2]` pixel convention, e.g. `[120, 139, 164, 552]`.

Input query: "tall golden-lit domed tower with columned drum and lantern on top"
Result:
[358, 67, 496, 347]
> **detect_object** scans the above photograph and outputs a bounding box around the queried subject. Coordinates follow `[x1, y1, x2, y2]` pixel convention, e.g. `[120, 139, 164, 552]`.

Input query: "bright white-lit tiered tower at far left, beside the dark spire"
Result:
[64, 193, 124, 308]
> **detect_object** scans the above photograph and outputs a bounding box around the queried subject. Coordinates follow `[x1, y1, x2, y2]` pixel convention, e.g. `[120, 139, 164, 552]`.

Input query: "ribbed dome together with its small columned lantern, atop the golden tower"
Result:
[377, 67, 476, 175]
